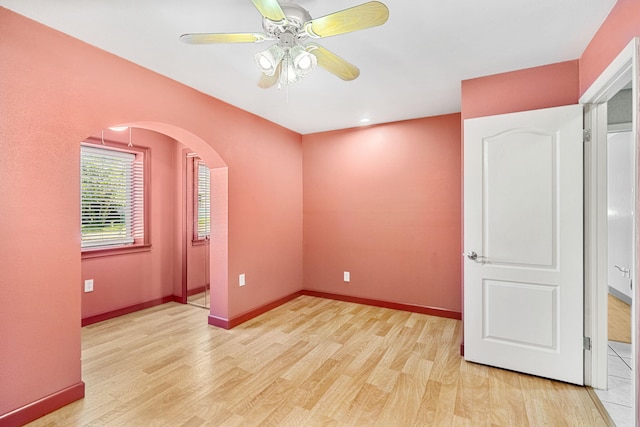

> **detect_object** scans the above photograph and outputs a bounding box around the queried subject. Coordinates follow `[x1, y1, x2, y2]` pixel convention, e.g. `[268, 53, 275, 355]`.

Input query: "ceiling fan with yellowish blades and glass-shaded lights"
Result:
[180, 0, 389, 88]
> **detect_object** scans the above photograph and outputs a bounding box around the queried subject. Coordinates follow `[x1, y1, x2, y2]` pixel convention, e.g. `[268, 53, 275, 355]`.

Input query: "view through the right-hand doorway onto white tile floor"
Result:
[596, 82, 635, 423]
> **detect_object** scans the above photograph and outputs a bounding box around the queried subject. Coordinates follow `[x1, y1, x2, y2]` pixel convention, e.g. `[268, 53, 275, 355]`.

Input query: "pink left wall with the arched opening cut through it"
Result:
[0, 8, 302, 416]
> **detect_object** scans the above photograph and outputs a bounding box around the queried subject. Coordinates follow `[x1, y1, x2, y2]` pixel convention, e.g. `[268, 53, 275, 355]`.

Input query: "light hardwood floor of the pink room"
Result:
[31, 296, 606, 426]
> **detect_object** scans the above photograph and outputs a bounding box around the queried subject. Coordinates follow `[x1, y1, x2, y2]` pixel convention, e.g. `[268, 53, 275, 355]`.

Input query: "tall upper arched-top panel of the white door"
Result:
[482, 130, 557, 267]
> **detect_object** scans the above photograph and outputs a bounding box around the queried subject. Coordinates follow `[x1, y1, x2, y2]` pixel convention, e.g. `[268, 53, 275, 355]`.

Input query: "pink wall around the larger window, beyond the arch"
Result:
[80, 129, 182, 318]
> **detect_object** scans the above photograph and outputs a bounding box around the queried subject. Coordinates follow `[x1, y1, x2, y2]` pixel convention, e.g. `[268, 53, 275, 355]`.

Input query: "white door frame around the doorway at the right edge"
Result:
[580, 37, 640, 417]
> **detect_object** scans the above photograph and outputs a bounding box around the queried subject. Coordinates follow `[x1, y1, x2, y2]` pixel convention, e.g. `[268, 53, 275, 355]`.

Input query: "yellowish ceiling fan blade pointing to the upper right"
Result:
[304, 1, 389, 38]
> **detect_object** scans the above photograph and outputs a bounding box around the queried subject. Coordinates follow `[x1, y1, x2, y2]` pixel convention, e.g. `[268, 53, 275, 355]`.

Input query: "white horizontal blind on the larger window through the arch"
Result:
[80, 145, 144, 248]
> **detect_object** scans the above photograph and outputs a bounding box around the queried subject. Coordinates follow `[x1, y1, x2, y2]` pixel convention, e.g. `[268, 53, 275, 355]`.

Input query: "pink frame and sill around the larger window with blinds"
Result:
[78, 137, 151, 259]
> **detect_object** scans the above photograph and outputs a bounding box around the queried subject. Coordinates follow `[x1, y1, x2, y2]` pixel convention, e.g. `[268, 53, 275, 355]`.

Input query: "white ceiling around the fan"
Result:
[0, 0, 615, 134]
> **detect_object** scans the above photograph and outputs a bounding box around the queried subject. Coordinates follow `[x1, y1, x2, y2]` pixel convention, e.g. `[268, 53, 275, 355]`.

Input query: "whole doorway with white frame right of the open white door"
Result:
[580, 39, 638, 425]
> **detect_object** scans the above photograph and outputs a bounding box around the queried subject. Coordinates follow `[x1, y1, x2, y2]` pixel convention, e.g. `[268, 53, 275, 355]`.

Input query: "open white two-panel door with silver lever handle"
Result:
[464, 105, 584, 384]
